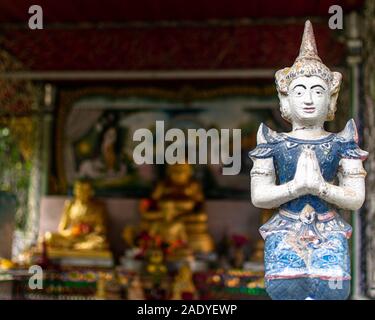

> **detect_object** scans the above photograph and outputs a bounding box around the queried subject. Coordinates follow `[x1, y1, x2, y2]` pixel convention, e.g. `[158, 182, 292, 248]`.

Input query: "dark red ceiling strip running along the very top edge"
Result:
[0, 0, 364, 23]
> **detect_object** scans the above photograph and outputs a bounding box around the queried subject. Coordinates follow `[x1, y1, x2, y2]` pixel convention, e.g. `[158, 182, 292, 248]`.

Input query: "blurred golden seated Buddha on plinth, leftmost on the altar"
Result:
[43, 181, 108, 251]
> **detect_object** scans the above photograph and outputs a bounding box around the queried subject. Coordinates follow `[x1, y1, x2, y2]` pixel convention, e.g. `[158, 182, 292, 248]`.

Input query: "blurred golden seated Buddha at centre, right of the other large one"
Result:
[141, 163, 214, 253]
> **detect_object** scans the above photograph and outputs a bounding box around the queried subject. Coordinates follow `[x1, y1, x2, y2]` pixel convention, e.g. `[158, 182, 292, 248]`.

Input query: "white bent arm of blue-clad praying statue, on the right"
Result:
[319, 159, 366, 210]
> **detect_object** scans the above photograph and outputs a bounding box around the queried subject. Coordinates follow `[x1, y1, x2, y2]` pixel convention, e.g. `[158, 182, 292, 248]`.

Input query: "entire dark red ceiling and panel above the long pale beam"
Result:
[0, 0, 363, 71]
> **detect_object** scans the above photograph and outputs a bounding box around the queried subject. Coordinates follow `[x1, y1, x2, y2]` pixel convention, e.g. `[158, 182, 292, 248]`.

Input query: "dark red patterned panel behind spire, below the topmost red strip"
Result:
[3, 23, 345, 70]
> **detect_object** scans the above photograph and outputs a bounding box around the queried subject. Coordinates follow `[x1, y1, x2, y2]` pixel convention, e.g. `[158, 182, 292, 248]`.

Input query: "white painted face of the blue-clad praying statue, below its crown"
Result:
[287, 76, 330, 125]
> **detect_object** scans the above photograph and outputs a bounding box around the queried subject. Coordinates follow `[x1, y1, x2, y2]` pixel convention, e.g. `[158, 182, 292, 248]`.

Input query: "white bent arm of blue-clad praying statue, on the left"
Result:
[250, 158, 300, 209]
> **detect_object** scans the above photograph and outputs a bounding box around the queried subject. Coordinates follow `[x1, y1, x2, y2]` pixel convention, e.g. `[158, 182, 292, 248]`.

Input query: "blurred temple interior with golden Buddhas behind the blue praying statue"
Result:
[0, 0, 375, 300]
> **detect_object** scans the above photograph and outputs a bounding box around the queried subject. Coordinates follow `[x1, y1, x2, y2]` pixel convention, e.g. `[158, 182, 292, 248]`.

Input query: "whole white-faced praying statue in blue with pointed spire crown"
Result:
[249, 21, 367, 300]
